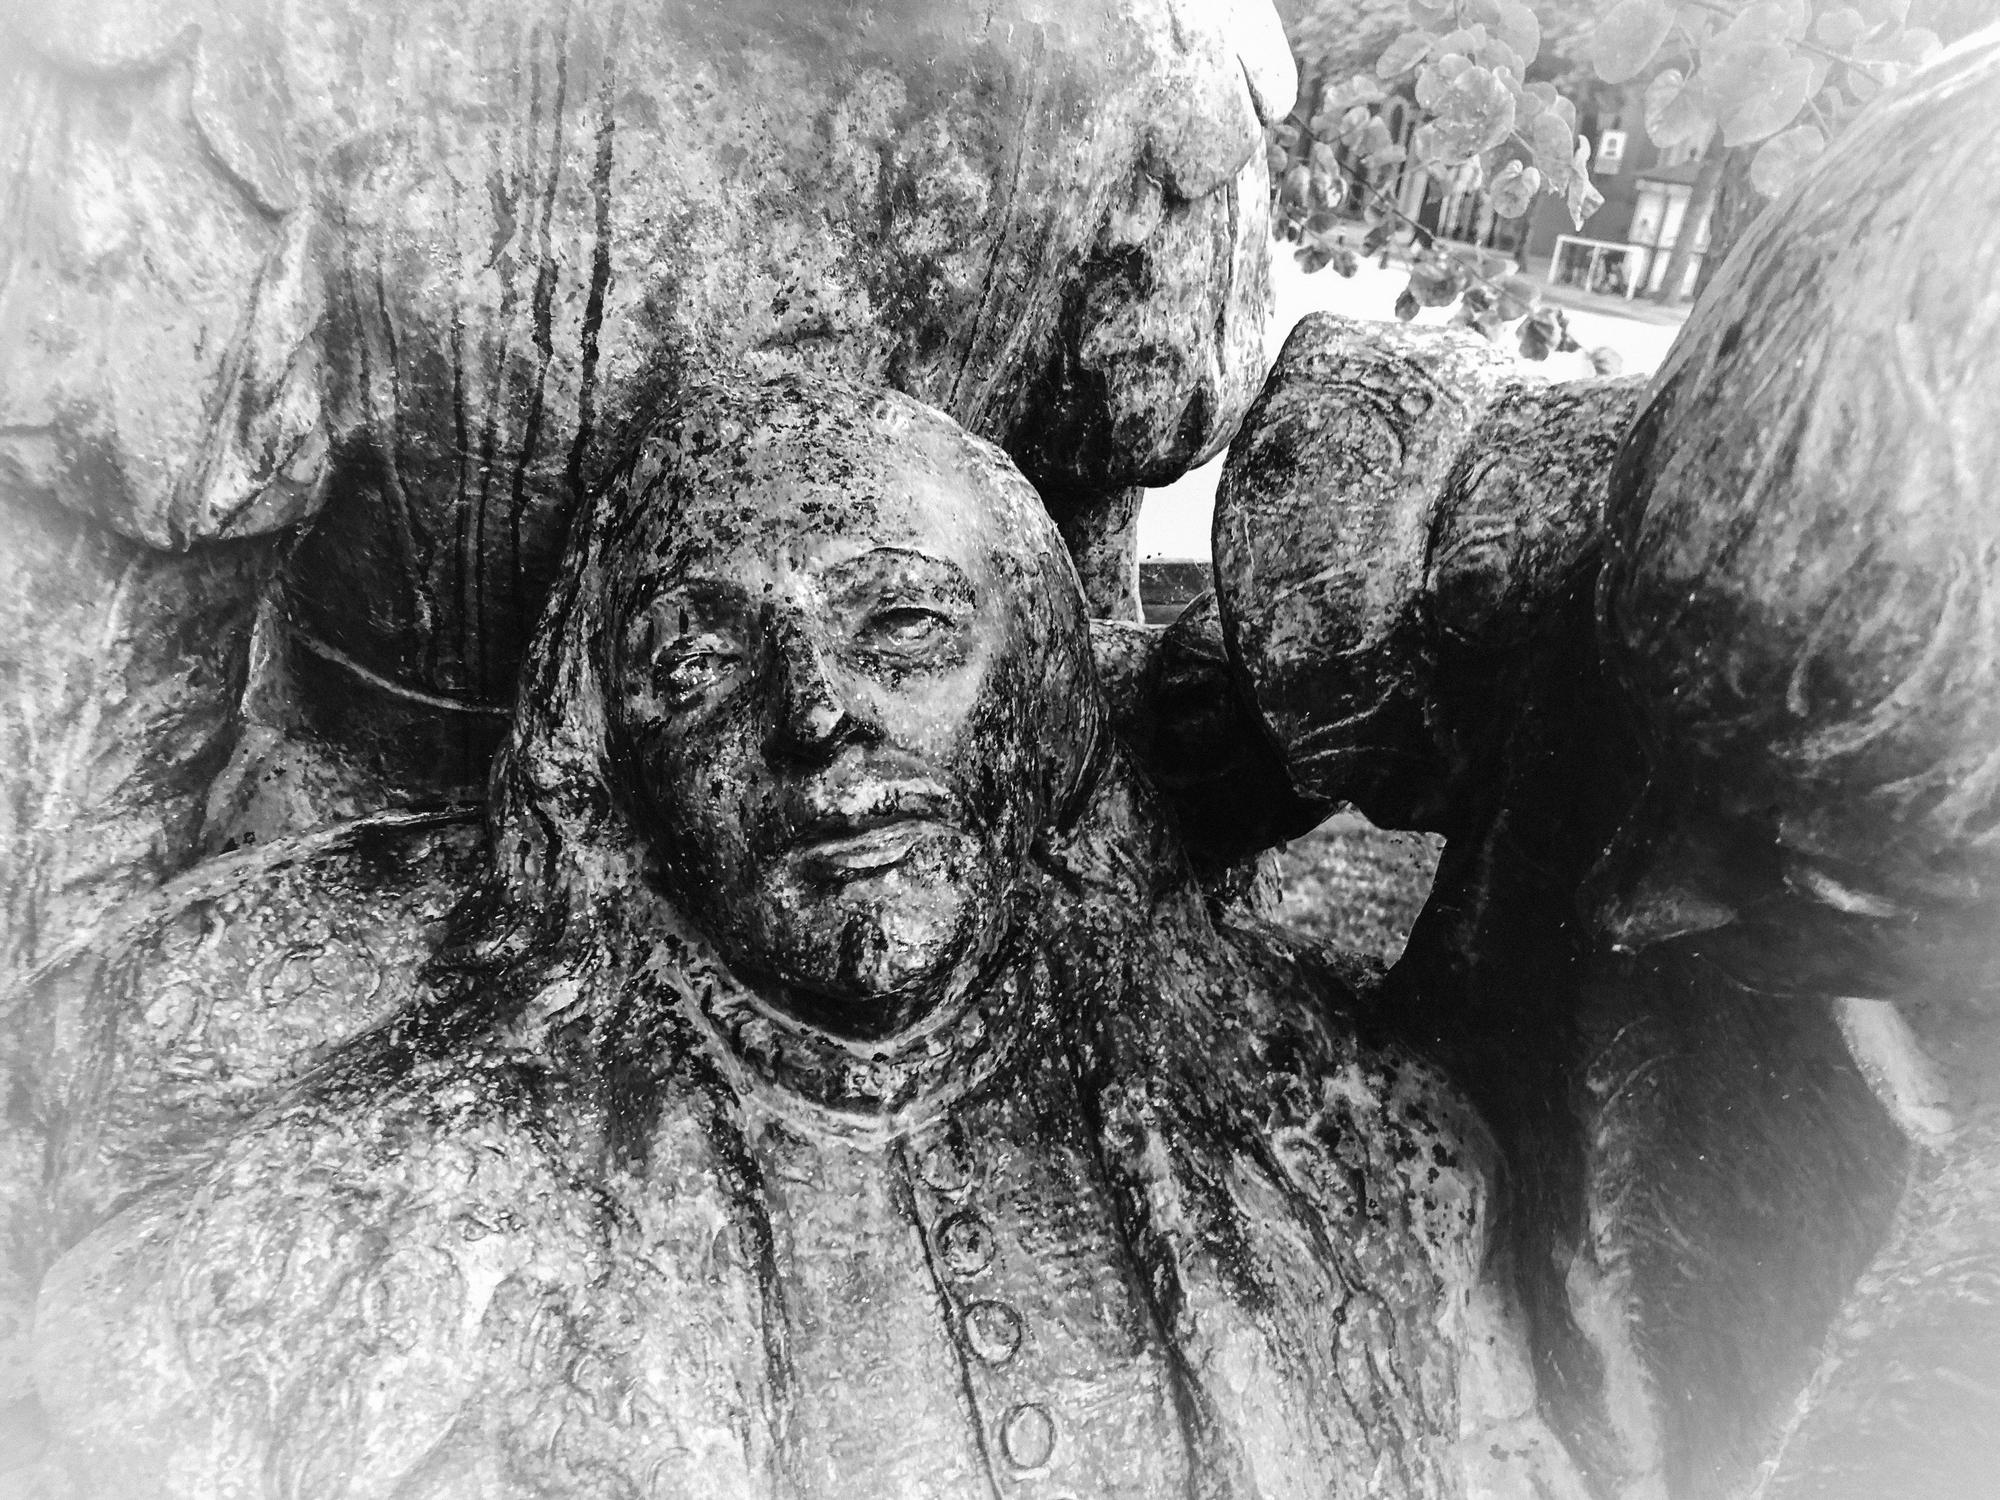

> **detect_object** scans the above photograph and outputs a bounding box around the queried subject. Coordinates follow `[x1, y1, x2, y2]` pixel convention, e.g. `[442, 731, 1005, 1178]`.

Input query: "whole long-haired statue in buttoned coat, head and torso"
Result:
[7, 376, 1584, 1498]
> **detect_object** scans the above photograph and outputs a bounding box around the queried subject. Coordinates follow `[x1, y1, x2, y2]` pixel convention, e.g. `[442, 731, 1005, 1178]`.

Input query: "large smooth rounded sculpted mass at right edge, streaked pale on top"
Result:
[1602, 38, 2000, 920]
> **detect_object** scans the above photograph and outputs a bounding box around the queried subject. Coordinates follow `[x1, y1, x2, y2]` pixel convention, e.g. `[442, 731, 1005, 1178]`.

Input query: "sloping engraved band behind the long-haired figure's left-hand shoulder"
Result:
[0, 814, 484, 1482]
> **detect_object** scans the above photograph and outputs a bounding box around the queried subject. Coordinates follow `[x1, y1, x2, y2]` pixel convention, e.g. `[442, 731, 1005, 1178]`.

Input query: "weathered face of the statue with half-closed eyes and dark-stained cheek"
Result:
[608, 388, 1094, 1038]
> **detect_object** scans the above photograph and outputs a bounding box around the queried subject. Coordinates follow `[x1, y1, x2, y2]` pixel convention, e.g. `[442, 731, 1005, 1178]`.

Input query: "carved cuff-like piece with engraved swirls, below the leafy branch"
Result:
[1214, 316, 1640, 832]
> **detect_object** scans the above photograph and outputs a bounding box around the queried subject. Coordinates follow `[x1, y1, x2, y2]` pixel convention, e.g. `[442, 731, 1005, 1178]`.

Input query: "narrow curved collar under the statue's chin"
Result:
[694, 934, 1052, 1136]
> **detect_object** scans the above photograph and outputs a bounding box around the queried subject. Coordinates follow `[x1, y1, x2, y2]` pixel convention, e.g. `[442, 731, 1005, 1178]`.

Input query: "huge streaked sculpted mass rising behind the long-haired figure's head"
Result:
[0, 0, 1294, 1024]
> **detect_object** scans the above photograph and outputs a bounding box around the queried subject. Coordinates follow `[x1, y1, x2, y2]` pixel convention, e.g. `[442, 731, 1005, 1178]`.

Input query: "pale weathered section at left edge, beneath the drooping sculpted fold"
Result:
[0, 498, 276, 994]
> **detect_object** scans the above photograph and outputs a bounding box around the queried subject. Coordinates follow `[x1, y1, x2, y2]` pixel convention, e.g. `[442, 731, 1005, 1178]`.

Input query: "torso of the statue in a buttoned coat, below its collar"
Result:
[15, 816, 1564, 1500]
